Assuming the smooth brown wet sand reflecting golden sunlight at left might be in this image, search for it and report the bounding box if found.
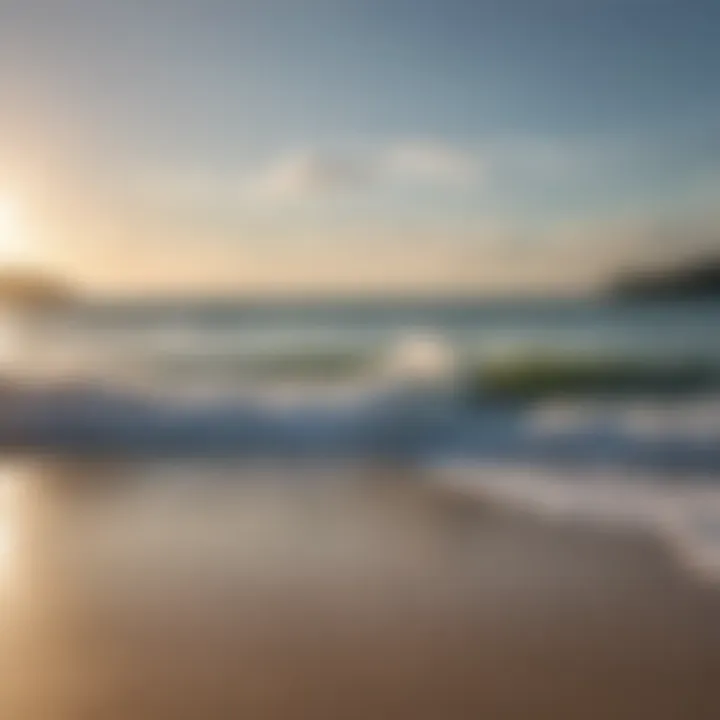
[0,465,720,720]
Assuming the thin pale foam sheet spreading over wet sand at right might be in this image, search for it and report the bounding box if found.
[435,463,720,583]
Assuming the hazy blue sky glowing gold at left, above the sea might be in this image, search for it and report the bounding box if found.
[0,0,720,294]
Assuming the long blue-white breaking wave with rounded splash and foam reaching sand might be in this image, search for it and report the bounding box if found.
[5,335,720,581]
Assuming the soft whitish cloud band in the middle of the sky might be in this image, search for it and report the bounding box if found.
[244,136,592,202]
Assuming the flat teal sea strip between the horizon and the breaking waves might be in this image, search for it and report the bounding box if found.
[71,299,720,379]
